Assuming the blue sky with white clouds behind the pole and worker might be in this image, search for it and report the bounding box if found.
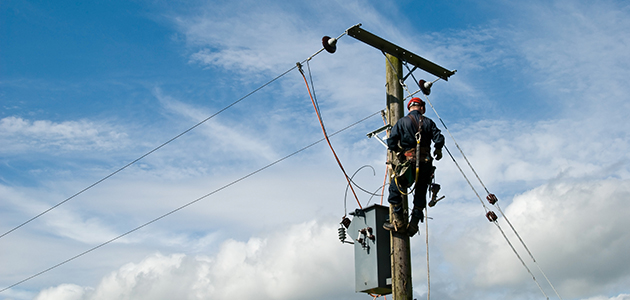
[0,0,630,300]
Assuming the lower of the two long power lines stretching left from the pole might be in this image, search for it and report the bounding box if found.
[0,110,380,293]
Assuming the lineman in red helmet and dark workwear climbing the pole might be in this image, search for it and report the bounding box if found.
[383,98,444,236]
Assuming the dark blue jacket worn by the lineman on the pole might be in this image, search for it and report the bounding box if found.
[387,110,444,151]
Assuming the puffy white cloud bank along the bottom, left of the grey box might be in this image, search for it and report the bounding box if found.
[35,221,360,300]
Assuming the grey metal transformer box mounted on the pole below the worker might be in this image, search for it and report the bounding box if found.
[348,204,392,295]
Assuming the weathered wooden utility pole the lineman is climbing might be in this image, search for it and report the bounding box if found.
[385,54,413,300]
